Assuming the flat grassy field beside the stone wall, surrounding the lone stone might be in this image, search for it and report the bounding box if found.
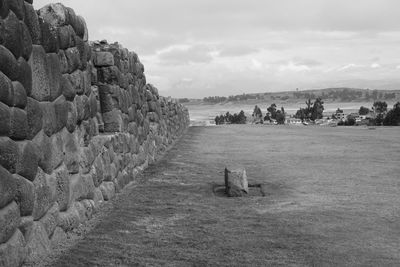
[42,125,400,266]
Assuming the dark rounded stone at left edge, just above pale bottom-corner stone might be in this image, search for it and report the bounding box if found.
[0,201,21,244]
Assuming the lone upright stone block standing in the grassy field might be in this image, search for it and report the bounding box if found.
[225,168,249,197]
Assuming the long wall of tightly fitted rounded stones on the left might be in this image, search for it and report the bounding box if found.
[0,0,189,266]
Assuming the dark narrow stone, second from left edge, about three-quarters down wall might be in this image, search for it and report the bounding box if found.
[13,174,35,216]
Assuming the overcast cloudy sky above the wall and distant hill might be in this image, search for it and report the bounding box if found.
[33,0,400,98]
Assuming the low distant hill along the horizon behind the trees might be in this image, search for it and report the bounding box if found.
[187,87,400,104]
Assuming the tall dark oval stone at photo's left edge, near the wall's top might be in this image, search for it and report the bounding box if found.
[4,11,23,58]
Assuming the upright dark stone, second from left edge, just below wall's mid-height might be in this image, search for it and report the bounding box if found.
[16,141,40,181]
